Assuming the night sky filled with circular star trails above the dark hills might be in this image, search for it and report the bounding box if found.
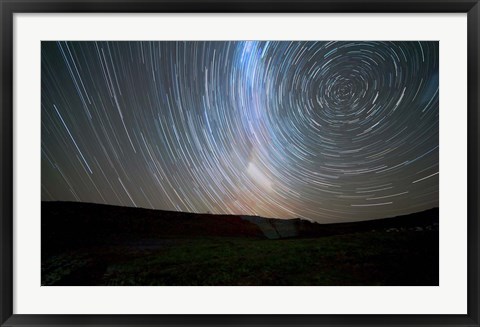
[41,41,439,222]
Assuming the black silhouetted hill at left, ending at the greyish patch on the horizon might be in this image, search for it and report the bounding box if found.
[41,202,264,254]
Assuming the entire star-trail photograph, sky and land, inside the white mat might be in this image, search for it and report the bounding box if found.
[41,41,439,286]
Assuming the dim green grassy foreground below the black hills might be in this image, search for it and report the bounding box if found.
[42,230,439,286]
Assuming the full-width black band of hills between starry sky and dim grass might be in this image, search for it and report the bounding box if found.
[42,202,438,248]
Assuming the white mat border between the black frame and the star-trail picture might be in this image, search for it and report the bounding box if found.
[14,14,464,314]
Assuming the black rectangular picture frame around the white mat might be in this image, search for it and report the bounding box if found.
[0,0,480,327]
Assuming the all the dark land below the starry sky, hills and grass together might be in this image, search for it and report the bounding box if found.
[41,202,439,286]
